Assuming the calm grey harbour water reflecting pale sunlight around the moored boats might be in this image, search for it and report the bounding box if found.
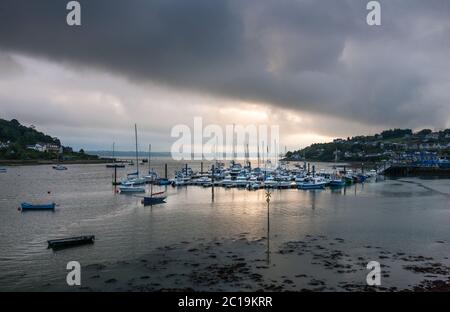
[0,159,450,291]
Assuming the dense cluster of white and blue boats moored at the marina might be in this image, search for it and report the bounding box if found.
[120,162,377,192]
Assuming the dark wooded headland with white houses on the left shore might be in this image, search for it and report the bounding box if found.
[0,118,98,160]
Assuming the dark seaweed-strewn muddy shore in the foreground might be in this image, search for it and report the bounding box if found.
[21,232,450,292]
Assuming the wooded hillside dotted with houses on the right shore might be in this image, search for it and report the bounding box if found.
[285,129,450,161]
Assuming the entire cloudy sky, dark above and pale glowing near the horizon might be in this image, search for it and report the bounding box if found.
[0,0,450,151]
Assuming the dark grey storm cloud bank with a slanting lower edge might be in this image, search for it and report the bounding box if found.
[0,0,450,127]
